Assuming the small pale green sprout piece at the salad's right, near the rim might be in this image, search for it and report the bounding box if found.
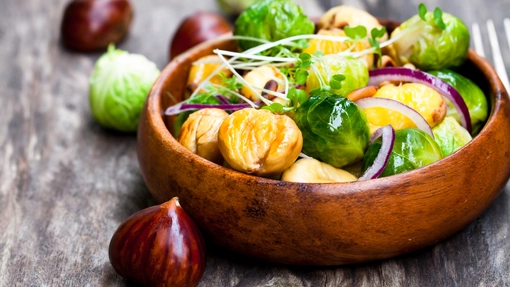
[432,117,472,157]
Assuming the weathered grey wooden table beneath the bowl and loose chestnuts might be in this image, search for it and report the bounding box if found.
[0,0,510,286]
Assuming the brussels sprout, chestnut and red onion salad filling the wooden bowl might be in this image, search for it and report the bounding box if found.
[166,0,488,183]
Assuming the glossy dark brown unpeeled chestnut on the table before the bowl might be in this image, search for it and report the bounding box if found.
[109,197,205,287]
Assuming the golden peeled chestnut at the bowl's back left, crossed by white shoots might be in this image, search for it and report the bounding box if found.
[187,55,232,95]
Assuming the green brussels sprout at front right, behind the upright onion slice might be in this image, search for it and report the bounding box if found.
[361,128,443,177]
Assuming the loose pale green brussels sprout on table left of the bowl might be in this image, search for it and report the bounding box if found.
[89,45,160,132]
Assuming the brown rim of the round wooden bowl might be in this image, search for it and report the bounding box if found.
[145,31,509,193]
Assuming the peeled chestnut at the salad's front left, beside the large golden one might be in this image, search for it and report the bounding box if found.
[179,109,228,164]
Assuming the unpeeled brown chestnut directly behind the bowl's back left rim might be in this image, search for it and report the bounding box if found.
[169,11,232,60]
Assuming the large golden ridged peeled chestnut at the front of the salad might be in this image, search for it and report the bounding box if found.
[218,109,303,176]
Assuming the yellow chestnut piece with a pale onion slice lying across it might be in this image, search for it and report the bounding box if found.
[364,83,446,132]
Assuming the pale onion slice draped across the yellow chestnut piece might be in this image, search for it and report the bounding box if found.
[355,97,434,138]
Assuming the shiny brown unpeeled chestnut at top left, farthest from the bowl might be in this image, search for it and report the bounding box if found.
[61,0,133,52]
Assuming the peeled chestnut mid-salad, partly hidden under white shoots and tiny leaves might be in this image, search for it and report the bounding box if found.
[241,66,283,101]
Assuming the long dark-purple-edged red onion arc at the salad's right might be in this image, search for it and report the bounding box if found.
[368,67,471,133]
